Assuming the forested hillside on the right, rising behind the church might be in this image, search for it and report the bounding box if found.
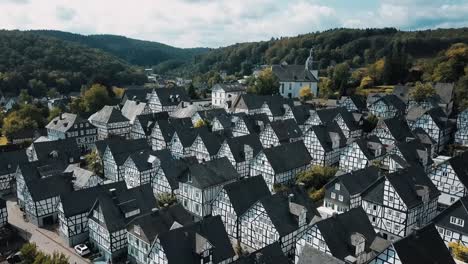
[174,28,468,75]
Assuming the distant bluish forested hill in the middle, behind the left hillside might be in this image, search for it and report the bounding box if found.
[30,30,208,67]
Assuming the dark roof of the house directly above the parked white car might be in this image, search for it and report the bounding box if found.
[60,181,127,217]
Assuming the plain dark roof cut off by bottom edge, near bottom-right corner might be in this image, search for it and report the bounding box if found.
[393,224,455,264]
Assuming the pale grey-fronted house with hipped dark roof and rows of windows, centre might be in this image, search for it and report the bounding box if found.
[177,158,240,218]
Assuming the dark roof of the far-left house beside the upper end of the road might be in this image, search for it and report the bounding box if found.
[25,173,73,202]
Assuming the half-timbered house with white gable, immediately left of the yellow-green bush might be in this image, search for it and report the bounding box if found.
[250,141,312,192]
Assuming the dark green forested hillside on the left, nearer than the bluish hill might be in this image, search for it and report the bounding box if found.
[0,30,146,97]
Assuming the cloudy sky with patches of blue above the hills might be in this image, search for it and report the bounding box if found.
[0,0,468,47]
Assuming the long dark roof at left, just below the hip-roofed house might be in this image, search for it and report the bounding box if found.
[32,138,81,162]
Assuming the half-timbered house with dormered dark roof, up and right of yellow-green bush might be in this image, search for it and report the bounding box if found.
[339,136,386,172]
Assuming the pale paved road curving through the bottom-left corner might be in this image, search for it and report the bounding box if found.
[7,199,90,264]
